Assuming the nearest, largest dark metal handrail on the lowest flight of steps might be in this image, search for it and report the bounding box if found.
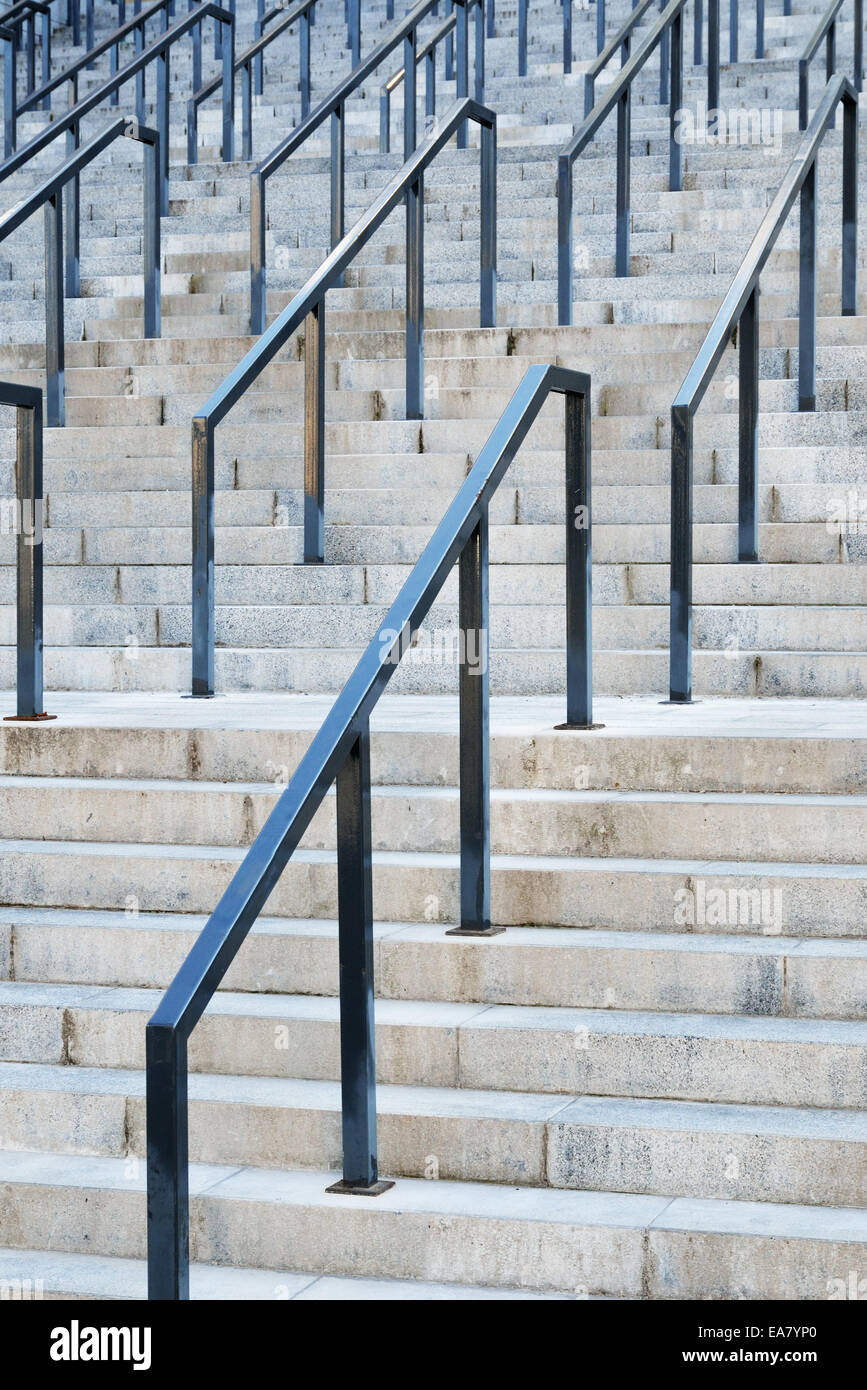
[146,366,592,1300]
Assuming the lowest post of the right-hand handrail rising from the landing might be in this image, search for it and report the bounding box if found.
[668,406,692,705]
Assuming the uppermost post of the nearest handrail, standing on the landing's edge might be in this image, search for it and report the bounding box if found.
[565,392,593,728]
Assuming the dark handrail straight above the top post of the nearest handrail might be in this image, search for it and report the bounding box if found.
[557,0,686,316]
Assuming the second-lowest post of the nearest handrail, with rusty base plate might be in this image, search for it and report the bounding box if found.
[328,721,392,1197]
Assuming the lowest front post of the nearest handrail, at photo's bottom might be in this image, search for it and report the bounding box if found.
[145,1024,189,1301]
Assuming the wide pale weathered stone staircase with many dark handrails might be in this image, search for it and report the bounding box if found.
[0,0,867,1300]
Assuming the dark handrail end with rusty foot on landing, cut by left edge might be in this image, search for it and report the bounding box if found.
[0,381,49,719]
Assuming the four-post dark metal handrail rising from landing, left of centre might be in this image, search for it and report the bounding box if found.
[193,97,496,695]
